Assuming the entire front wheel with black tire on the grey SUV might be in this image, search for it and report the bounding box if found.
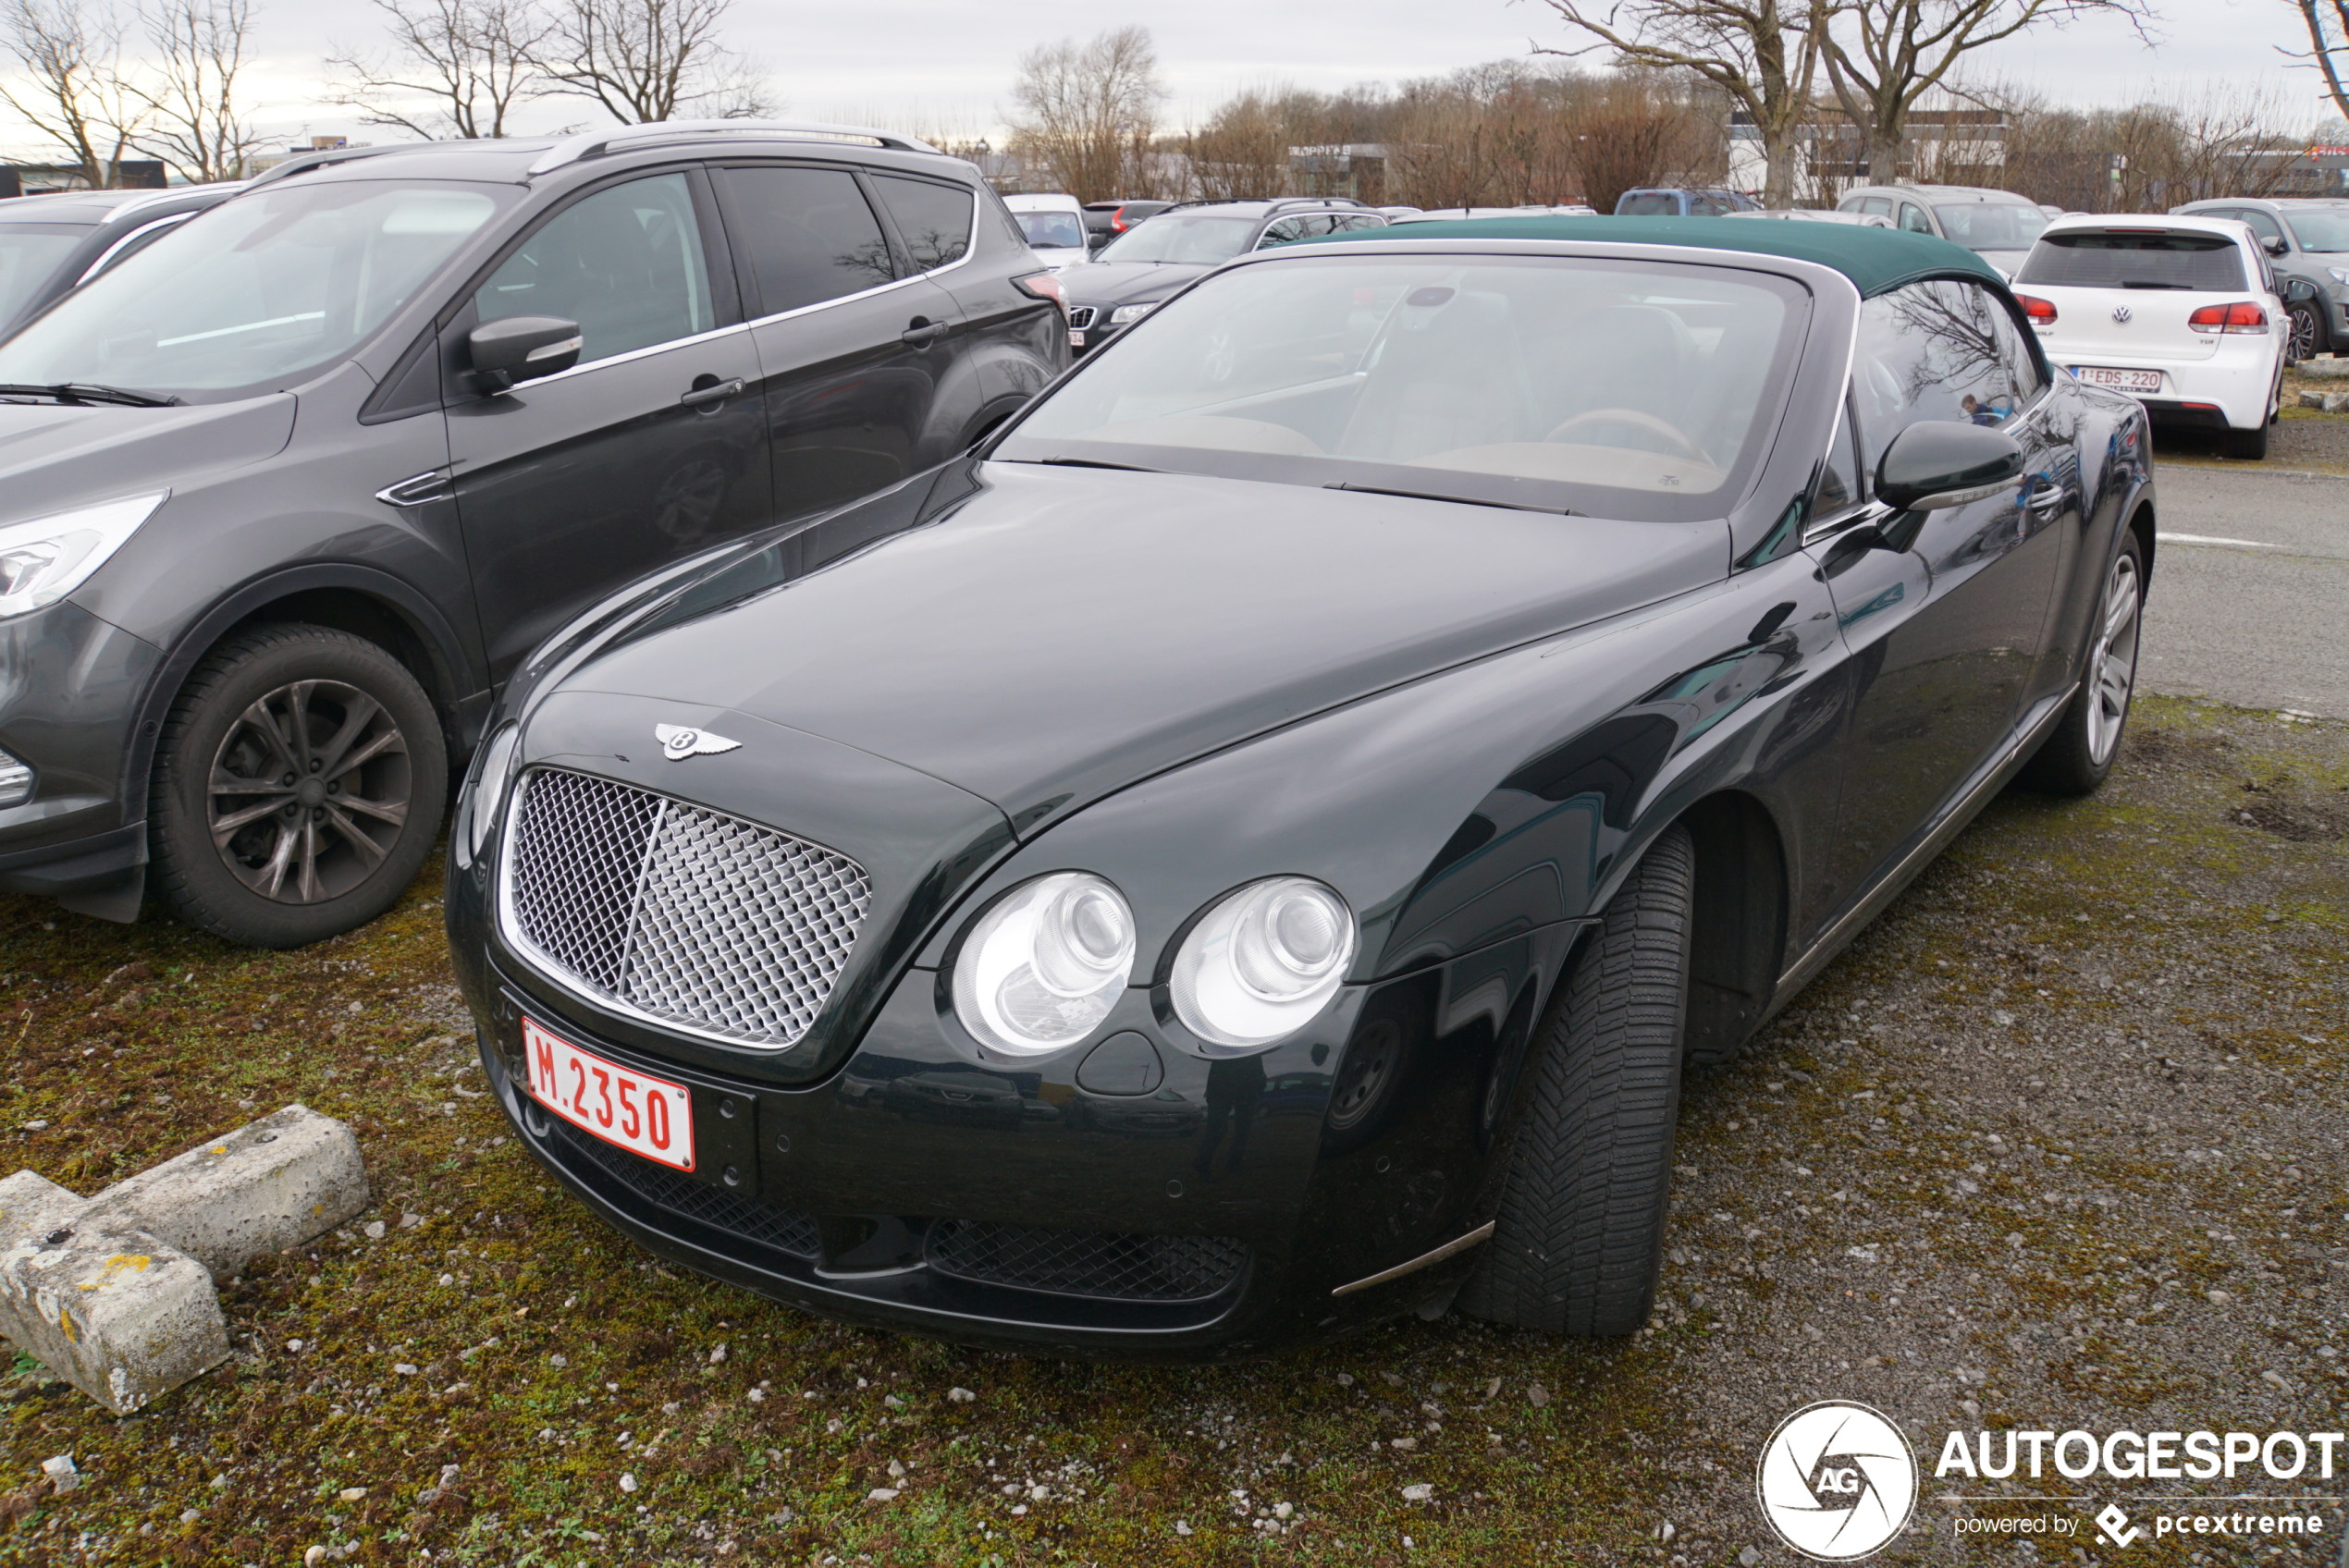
[148,624,449,949]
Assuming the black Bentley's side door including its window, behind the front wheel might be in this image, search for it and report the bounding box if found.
[1809,279,2079,892]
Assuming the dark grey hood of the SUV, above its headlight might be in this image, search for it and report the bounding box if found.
[0,392,294,521]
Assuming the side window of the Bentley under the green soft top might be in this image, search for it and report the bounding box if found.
[1853,279,2041,472]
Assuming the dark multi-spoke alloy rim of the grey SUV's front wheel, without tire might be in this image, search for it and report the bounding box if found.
[207,680,413,903]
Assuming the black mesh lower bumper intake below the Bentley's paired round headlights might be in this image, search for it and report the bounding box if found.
[926,1220,1248,1303]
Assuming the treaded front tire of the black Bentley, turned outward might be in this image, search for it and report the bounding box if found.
[1458,827,1696,1336]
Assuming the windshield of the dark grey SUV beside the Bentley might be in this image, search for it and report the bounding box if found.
[0,180,519,395]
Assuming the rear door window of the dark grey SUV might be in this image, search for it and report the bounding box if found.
[726,165,897,317]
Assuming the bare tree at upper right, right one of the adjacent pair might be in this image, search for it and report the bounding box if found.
[1811,0,2152,186]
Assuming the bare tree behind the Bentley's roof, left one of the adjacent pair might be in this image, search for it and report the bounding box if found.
[1543,0,1821,206]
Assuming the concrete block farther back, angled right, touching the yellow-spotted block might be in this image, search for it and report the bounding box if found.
[94,1106,371,1280]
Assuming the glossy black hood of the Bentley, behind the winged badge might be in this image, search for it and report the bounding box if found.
[561,462,1728,838]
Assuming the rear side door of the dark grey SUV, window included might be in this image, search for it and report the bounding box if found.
[719,162,967,519]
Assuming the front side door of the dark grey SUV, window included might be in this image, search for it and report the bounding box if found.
[449,169,769,680]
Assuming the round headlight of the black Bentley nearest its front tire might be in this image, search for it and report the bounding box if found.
[1170,876,1356,1047]
